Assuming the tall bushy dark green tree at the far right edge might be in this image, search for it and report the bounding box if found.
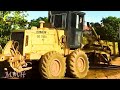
[101,16,120,41]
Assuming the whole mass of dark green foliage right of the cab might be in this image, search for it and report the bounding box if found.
[92,16,120,41]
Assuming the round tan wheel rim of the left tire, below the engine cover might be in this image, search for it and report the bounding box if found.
[50,59,61,76]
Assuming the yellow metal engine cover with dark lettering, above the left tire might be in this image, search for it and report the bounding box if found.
[19,28,64,60]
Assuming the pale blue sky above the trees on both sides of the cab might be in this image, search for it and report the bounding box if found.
[27,11,120,22]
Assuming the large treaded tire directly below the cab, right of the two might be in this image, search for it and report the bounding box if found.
[67,49,89,78]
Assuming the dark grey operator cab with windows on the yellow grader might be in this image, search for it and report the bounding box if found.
[48,11,85,49]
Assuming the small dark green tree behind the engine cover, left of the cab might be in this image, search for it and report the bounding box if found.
[29,17,48,28]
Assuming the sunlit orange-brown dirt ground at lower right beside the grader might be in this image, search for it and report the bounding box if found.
[65,57,120,79]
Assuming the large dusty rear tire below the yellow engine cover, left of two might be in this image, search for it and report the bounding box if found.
[39,51,66,79]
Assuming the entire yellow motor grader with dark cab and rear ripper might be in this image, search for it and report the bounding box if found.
[0,11,111,79]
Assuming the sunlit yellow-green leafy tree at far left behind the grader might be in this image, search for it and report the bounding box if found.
[0,11,27,47]
